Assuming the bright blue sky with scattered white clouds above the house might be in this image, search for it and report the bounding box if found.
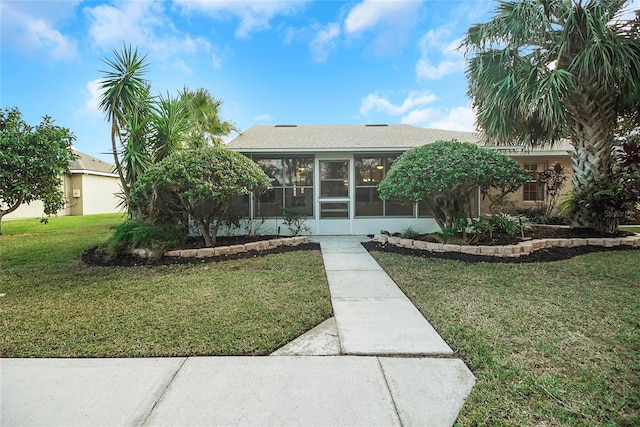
[0,0,640,161]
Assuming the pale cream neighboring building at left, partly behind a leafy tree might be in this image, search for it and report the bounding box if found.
[3,148,120,219]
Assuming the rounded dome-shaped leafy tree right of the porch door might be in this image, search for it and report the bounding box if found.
[378,141,529,230]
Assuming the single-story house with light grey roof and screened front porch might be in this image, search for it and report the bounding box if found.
[227,124,571,235]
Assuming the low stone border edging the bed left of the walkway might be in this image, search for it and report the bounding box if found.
[131,236,309,259]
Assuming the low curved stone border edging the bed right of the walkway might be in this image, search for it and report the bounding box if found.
[372,234,640,258]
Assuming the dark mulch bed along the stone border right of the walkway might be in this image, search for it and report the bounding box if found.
[363,226,636,263]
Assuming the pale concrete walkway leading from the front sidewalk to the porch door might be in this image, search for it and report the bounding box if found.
[0,237,475,426]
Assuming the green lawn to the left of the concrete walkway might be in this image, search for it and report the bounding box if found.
[0,215,332,357]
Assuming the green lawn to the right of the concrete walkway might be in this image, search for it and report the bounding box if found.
[373,250,640,426]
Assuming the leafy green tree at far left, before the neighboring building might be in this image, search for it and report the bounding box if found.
[0,107,75,234]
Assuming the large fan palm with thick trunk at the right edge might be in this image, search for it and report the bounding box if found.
[462,0,640,232]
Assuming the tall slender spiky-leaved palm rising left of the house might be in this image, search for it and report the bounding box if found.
[100,46,150,212]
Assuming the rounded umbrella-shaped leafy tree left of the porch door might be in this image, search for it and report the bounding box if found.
[132,147,270,246]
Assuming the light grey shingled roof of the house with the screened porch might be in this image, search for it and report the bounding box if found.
[227,124,572,156]
